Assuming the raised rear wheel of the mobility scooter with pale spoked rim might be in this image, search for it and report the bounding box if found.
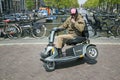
[86,46,98,60]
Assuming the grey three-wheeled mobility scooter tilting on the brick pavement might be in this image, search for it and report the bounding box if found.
[40,27,98,71]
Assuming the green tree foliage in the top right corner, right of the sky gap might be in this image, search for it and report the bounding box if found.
[84,0,120,12]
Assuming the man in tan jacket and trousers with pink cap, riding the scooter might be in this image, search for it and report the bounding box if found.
[56,8,85,57]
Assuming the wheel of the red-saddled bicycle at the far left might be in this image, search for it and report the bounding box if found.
[5,24,21,39]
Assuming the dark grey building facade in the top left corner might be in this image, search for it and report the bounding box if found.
[0,0,25,14]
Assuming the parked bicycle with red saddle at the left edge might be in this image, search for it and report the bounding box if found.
[0,19,20,39]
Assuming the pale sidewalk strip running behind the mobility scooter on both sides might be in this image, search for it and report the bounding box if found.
[0,37,120,46]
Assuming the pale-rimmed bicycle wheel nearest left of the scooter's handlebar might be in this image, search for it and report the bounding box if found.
[32,24,47,38]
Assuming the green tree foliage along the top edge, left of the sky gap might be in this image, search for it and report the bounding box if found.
[25,0,79,10]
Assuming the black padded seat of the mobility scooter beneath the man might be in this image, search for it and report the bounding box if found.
[66,37,87,45]
